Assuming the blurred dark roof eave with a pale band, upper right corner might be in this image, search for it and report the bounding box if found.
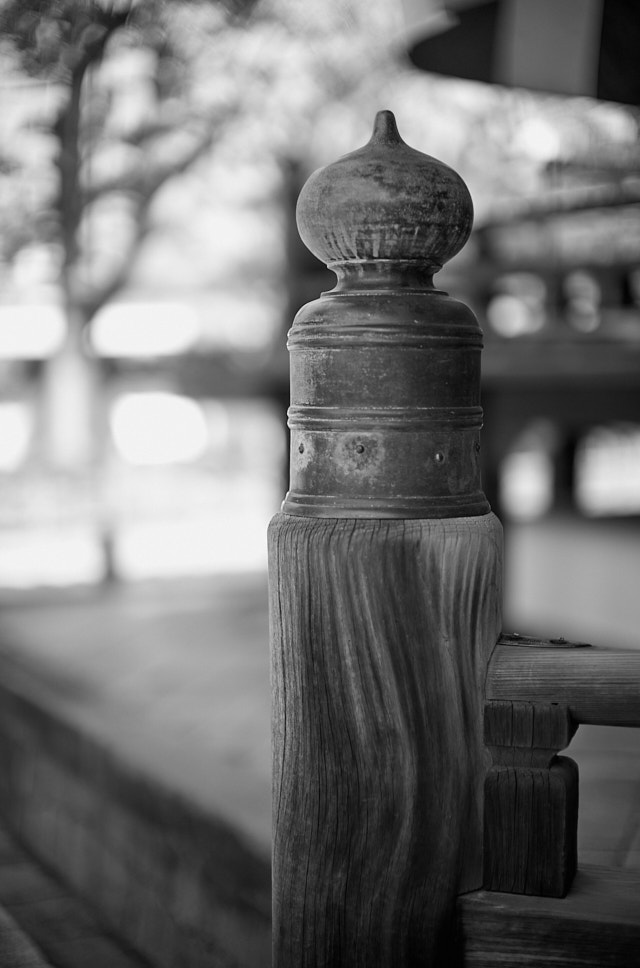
[402,0,640,107]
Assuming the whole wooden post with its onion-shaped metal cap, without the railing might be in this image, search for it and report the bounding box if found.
[269,111,502,968]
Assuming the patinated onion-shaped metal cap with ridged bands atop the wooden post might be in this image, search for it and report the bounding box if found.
[283,111,489,518]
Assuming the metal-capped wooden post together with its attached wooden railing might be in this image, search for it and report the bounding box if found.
[269,112,640,968]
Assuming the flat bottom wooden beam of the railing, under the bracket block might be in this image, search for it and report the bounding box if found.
[458,867,640,968]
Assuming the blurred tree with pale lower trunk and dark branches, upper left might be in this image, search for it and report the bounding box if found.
[0,0,253,468]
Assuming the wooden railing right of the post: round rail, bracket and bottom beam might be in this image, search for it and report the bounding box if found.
[458,635,640,968]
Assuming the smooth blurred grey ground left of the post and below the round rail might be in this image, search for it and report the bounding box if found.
[0,574,640,869]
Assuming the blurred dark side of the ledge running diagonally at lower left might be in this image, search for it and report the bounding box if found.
[0,672,270,968]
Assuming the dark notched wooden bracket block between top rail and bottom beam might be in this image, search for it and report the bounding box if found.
[484,701,578,897]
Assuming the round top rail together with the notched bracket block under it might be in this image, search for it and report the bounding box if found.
[484,635,640,896]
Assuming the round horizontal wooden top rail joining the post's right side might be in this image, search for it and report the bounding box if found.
[485,636,640,726]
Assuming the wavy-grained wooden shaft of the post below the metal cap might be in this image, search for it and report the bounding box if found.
[269,514,502,968]
